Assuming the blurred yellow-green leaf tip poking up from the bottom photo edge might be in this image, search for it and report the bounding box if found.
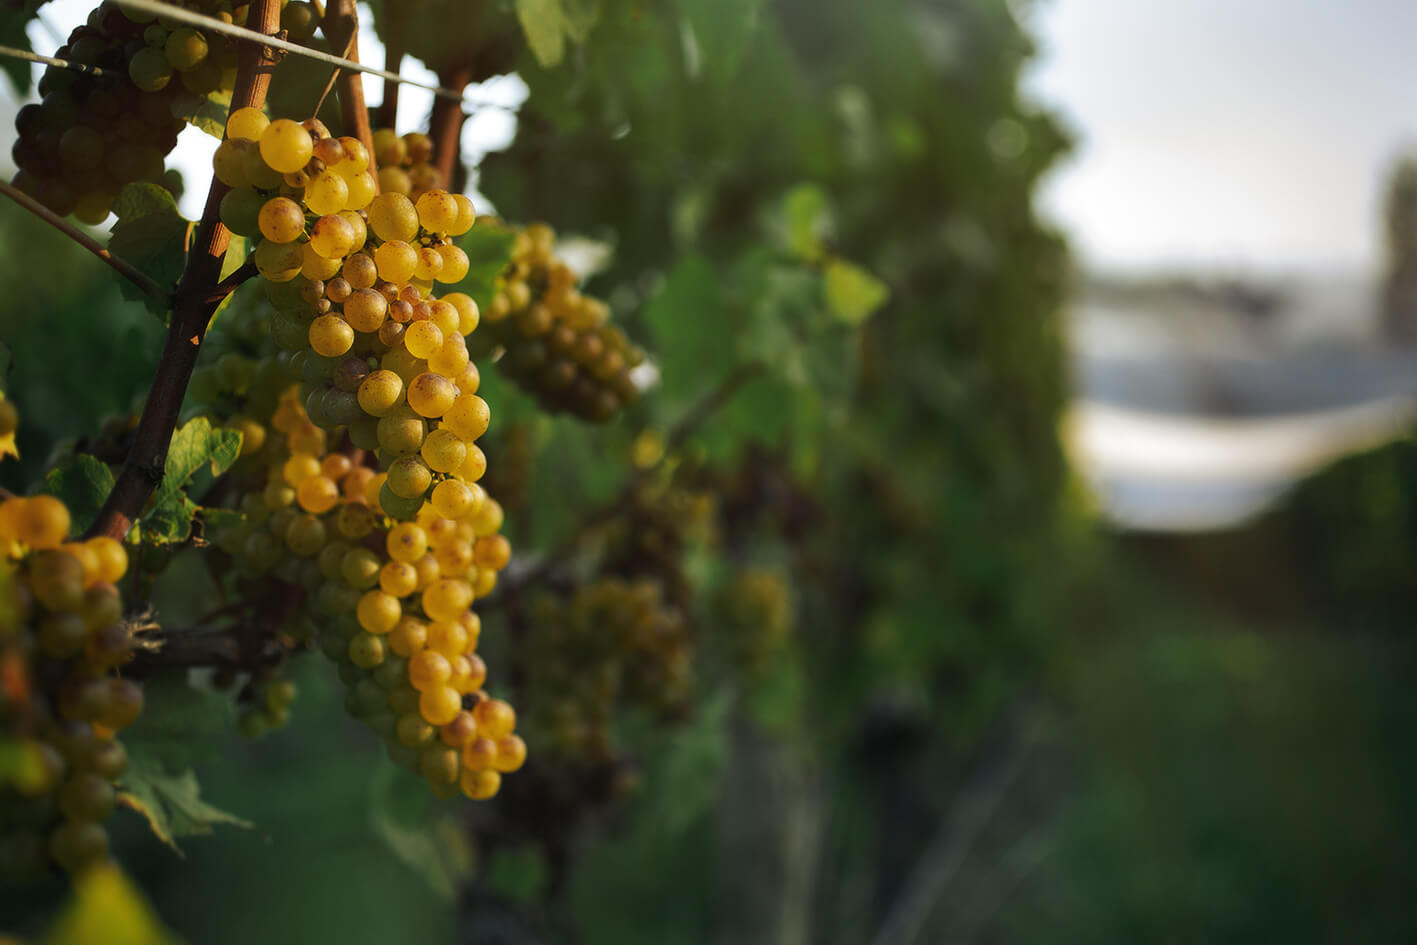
[41,864,181,945]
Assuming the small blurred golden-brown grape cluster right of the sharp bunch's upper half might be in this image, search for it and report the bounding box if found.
[482,224,645,422]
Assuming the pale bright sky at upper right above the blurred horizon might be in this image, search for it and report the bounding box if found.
[1029,0,1417,269]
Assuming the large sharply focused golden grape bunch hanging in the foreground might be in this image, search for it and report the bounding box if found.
[198,109,526,799]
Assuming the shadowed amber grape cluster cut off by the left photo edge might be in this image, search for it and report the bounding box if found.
[0,496,143,880]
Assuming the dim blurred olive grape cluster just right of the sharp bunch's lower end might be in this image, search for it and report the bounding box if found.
[530,578,693,762]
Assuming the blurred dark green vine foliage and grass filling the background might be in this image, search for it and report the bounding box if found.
[0,0,1417,945]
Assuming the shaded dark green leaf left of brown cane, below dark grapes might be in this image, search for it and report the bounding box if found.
[108,183,188,320]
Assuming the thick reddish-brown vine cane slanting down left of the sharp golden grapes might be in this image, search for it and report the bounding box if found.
[88,0,281,538]
